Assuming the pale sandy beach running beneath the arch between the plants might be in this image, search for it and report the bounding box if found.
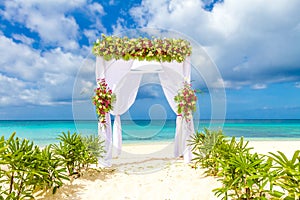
[39,141,300,200]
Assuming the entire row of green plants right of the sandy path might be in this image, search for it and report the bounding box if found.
[190,129,286,200]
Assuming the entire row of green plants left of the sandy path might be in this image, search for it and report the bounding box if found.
[0,132,103,200]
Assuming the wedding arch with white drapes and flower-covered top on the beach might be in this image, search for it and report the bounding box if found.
[93,35,196,166]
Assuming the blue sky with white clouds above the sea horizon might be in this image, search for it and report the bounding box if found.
[0,0,300,120]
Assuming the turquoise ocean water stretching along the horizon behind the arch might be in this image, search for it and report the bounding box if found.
[0,119,300,146]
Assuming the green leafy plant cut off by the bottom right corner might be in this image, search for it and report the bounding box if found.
[270,150,300,200]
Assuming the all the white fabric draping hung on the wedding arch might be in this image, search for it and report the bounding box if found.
[95,57,194,163]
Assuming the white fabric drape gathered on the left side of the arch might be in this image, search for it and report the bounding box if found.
[96,57,142,160]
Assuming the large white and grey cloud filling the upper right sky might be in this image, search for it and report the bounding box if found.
[130,0,300,87]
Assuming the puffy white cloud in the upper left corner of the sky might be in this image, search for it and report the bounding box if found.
[2,0,85,50]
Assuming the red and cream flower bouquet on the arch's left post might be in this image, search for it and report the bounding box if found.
[92,78,116,125]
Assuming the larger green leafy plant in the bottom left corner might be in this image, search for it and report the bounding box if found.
[0,133,67,199]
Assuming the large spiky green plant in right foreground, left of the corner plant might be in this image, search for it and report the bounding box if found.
[213,151,272,200]
